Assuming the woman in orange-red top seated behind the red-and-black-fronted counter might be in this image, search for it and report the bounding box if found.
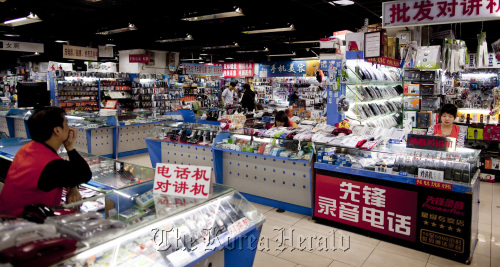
[427,104,467,147]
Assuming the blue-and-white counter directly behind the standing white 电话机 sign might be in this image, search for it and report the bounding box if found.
[146,122,220,171]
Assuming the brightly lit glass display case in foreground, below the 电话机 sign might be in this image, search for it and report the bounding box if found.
[57,182,265,266]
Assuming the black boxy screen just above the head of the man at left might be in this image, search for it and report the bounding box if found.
[17,82,50,109]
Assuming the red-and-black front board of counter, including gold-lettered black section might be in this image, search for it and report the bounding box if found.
[314,169,479,262]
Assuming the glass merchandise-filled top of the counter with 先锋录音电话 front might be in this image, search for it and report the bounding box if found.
[316,144,480,186]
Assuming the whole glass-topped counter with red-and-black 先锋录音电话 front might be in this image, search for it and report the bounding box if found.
[313,144,480,263]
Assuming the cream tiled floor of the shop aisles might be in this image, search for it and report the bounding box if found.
[120,154,500,267]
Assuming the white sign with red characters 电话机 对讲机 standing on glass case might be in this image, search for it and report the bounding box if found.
[153,163,212,198]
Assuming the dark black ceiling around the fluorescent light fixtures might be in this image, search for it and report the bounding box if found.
[0,0,500,69]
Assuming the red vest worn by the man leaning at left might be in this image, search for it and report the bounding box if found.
[0,142,63,216]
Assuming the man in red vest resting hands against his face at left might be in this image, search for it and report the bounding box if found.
[0,107,92,216]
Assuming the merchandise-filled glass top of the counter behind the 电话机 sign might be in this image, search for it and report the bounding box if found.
[148,122,220,146]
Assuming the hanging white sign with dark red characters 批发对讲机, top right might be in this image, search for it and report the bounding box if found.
[382,0,500,28]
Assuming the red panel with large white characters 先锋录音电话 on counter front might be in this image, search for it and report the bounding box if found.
[314,174,417,242]
